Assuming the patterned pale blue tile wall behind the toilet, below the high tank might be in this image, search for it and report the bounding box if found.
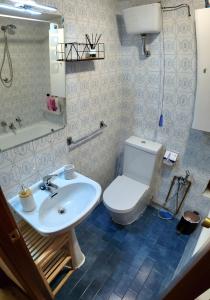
[119,0,210,215]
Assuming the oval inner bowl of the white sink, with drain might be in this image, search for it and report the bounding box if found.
[39,182,97,231]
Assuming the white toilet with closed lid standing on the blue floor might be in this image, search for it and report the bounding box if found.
[103,136,163,225]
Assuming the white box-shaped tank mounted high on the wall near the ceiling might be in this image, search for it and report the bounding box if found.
[123,3,162,34]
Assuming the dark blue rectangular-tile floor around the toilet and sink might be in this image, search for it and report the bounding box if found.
[56,204,188,300]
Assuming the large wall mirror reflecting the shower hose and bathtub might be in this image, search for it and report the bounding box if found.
[0,7,66,151]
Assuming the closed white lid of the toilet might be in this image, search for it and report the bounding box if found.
[103,175,149,213]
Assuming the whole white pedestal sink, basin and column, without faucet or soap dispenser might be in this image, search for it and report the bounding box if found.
[9,168,101,269]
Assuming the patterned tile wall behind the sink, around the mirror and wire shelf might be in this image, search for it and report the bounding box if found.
[0,0,124,197]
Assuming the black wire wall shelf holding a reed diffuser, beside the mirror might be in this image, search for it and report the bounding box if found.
[56,43,105,62]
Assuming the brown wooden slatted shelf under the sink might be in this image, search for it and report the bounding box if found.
[18,221,74,297]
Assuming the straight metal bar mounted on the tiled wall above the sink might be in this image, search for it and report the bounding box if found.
[67,121,107,150]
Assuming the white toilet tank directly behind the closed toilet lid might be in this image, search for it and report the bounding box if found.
[123,136,162,186]
